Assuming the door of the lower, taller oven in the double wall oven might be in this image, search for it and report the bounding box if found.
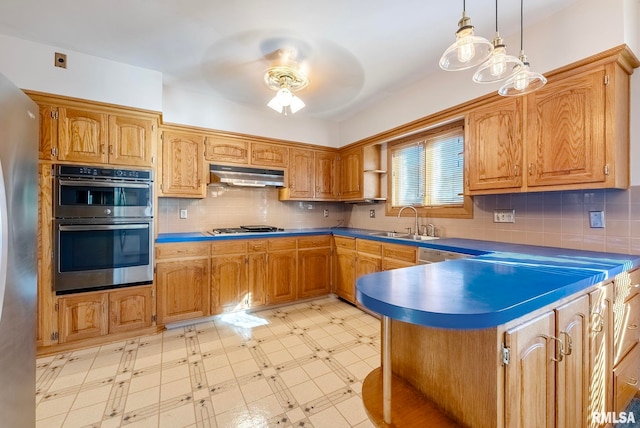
[53,219,153,294]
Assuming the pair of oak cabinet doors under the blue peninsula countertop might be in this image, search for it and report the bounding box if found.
[504,295,589,428]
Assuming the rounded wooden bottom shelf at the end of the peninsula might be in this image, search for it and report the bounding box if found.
[362,367,462,428]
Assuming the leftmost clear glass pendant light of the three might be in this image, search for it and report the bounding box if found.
[439,0,493,71]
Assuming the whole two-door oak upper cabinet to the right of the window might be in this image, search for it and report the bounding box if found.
[466,46,640,195]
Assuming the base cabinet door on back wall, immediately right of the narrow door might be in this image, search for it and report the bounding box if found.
[267,250,298,303]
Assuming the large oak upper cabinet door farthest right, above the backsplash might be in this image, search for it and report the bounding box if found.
[527,67,608,186]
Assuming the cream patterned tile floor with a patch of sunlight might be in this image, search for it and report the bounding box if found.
[36,297,380,428]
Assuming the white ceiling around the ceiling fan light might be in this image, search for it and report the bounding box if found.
[0,0,577,120]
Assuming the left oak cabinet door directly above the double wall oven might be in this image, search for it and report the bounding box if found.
[58,107,109,164]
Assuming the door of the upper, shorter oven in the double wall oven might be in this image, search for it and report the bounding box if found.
[53,178,153,218]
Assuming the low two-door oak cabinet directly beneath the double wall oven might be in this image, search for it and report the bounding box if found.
[58,285,153,343]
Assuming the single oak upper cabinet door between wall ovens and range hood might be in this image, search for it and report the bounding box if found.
[160,132,206,198]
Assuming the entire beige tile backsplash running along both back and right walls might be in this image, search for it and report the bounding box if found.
[156,186,640,254]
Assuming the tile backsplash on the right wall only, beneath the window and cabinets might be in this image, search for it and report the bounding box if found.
[346,186,640,254]
